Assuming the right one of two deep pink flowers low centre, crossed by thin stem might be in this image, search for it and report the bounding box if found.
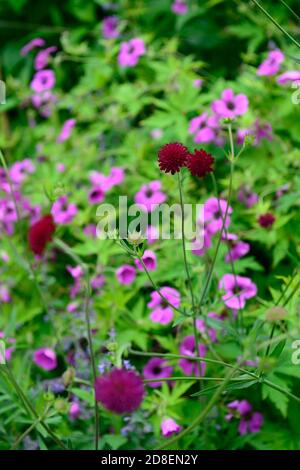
[178,336,206,376]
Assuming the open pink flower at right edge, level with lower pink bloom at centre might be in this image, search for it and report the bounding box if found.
[219,274,257,310]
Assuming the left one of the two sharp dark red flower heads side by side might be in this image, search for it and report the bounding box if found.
[158,142,189,175]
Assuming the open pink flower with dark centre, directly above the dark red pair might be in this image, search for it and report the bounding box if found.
[212,88,249,119]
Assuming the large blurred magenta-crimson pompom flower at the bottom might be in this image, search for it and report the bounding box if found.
[95,369,144,414]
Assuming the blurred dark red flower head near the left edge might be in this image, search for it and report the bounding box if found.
[28,214,55,256]
